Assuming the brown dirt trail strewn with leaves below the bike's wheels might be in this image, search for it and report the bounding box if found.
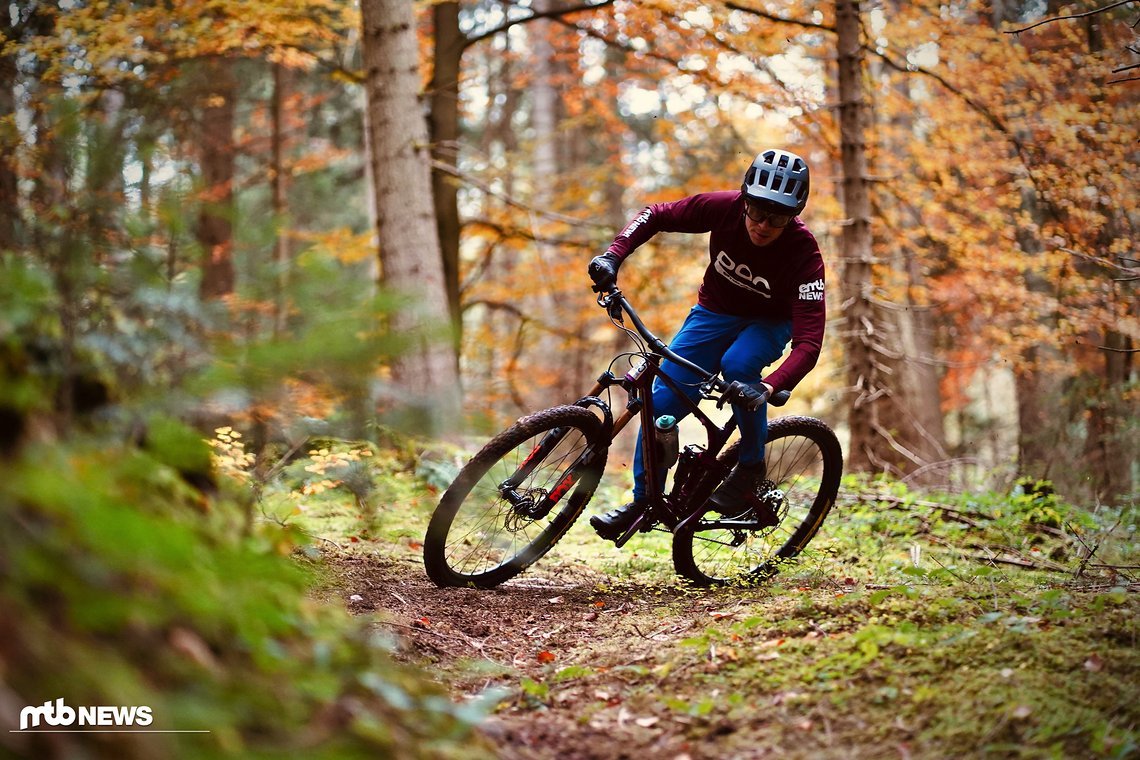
[334,555,787,760]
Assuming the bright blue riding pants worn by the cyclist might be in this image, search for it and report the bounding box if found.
[634,304,791,499]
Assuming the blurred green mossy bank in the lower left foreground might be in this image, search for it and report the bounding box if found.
[0,428,486,758]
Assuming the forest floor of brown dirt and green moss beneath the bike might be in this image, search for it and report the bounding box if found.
[326,510,1140,760]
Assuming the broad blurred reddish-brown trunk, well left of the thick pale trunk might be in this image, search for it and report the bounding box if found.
[195,58,237,299]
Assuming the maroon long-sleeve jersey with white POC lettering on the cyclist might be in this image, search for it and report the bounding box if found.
[610,190,827,391]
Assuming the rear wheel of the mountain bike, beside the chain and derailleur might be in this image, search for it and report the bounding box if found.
[673,417,844,586]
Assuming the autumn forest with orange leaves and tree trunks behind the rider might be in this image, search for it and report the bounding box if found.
[0,0,1140,500]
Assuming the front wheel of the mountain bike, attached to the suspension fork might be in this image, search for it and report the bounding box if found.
[424,406,609,588]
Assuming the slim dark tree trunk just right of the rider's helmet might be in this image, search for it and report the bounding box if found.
[836,0,886,472]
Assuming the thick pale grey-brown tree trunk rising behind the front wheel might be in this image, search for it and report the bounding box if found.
[360,0,461,434]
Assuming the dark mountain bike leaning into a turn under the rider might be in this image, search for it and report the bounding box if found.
[424,288,842,588]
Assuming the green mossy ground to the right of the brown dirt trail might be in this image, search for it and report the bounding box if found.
[673,582,1140,758]
